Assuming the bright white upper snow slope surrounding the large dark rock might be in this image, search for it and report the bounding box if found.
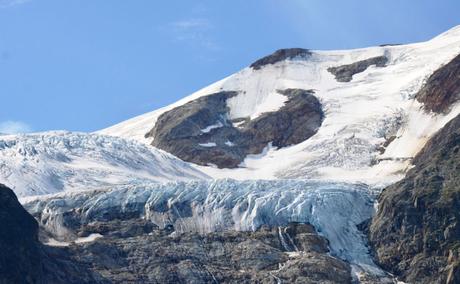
[101,26,460,186]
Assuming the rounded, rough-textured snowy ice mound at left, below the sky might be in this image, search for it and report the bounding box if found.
[0,132,207,196]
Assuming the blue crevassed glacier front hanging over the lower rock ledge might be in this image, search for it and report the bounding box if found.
[21,179,379,273]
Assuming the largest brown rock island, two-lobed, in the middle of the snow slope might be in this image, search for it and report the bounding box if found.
[146,89,324,168]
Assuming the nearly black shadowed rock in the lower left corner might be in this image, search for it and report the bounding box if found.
[0,184,109,284]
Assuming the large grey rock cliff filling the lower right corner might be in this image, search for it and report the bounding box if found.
[369,113,460,283]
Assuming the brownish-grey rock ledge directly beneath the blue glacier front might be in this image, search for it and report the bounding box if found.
[45,221,351,283]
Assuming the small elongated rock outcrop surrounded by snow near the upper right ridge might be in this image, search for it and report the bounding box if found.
[327,56,388,82]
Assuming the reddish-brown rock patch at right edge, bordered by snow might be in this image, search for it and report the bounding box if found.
[416,55,460,113]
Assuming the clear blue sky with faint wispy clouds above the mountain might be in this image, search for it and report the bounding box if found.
[0,0,460,133]
